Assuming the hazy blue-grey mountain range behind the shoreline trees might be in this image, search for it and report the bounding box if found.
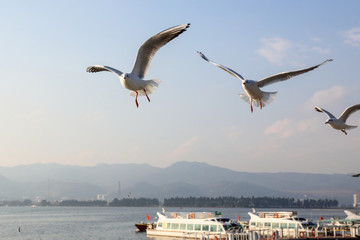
[0,162,360,204]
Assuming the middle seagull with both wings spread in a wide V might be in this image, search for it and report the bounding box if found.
[198,52,332,112]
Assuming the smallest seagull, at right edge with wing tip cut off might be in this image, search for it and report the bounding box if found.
[315,104,360,135]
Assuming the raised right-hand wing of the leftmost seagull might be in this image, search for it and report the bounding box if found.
[132,23,190,78]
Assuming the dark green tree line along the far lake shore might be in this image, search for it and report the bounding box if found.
[0,197,339,209]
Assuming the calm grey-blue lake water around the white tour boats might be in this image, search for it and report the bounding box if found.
[0,207,345,240]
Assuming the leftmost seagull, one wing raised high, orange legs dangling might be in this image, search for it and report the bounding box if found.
[86,23,190,107]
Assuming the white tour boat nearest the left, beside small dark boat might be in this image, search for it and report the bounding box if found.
[146,212,243,239]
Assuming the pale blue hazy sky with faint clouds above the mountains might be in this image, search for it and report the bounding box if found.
[0,0,360,173]
